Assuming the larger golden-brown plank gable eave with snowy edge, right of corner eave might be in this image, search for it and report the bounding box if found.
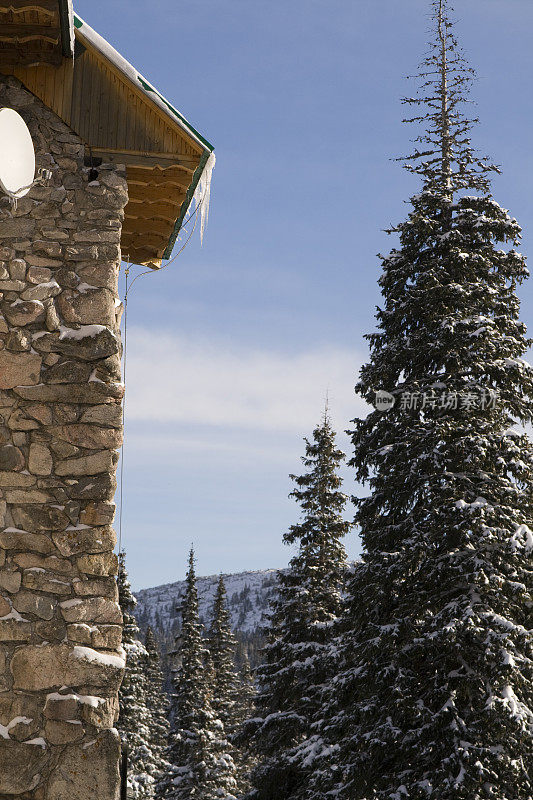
[0,11,213,268]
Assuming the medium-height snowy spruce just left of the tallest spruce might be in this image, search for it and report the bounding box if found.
[240,411,350,800]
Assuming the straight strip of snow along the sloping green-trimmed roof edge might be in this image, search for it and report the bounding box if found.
[74,14,214,153]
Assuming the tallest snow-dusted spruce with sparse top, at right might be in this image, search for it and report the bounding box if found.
[313,0,533,800]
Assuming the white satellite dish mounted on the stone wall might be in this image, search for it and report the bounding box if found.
[0,108,35,200]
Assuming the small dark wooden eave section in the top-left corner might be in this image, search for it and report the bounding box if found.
[0,0,72,70]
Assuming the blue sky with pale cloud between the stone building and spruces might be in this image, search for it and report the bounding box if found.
[76,0,533,588]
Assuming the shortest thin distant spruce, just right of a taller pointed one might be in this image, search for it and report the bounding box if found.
[208,575,242,735]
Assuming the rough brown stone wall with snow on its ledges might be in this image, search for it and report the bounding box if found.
[0,75,127,800]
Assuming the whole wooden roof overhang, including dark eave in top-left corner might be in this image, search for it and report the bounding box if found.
[0,7,213,269]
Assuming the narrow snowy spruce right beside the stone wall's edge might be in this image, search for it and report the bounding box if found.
[117,552,158,798]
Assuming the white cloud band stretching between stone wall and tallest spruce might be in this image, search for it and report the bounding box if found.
[127,328,366,434]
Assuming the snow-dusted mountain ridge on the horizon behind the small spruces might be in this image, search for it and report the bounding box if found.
[135,569,278,635]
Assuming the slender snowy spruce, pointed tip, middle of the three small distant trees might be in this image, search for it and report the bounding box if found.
[157,549,236,800]
